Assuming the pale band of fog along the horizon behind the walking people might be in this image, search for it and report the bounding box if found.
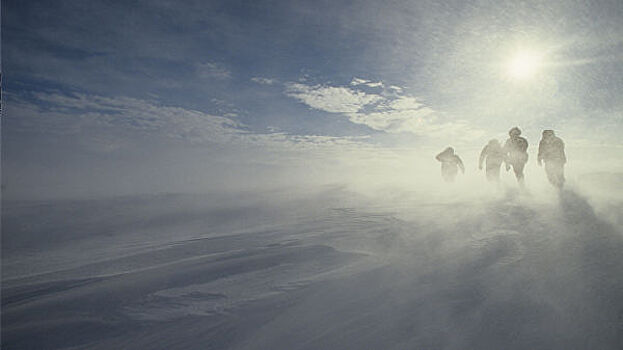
[3,123,623,200]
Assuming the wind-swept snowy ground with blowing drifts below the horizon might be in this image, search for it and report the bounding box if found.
[2,188,623,350]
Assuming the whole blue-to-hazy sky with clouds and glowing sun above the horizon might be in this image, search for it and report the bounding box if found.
[2,0,623,198]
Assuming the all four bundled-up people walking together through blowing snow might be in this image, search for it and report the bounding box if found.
[436,127,567,188]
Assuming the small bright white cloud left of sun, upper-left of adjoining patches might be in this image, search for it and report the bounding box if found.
[286,83,383,113]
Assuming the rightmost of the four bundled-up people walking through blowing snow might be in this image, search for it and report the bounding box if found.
[537,130,567,188]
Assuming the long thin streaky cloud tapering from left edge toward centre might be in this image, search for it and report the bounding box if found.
[6,92,366,150]
